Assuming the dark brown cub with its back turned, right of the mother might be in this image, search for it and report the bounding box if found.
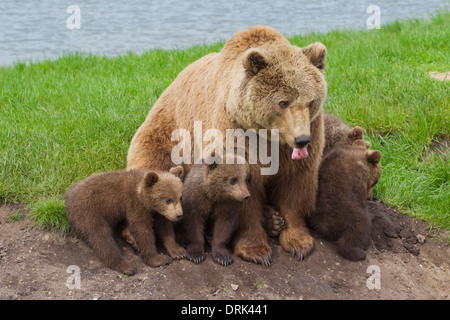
[308,145,382,261]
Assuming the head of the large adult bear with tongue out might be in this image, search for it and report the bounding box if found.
[238,44,326,148]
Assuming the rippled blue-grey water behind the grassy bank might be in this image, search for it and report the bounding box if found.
[0,0,448,65]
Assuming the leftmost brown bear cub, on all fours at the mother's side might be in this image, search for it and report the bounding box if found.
[64,166,184,275]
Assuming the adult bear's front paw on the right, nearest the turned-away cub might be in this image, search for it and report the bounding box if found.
[279,228,314,260]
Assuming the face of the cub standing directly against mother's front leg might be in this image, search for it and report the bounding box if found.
[206,163,250,202]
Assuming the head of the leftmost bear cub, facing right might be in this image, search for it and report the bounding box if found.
[138,167,183,221]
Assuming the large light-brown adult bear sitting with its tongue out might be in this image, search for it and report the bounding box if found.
[127,26,327,264]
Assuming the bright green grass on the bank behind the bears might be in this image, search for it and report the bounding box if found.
[0,11,450,231]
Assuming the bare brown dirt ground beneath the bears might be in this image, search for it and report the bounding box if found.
[0,201,450,300]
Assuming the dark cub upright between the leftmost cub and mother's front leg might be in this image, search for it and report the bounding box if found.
[183,152,250,266]
